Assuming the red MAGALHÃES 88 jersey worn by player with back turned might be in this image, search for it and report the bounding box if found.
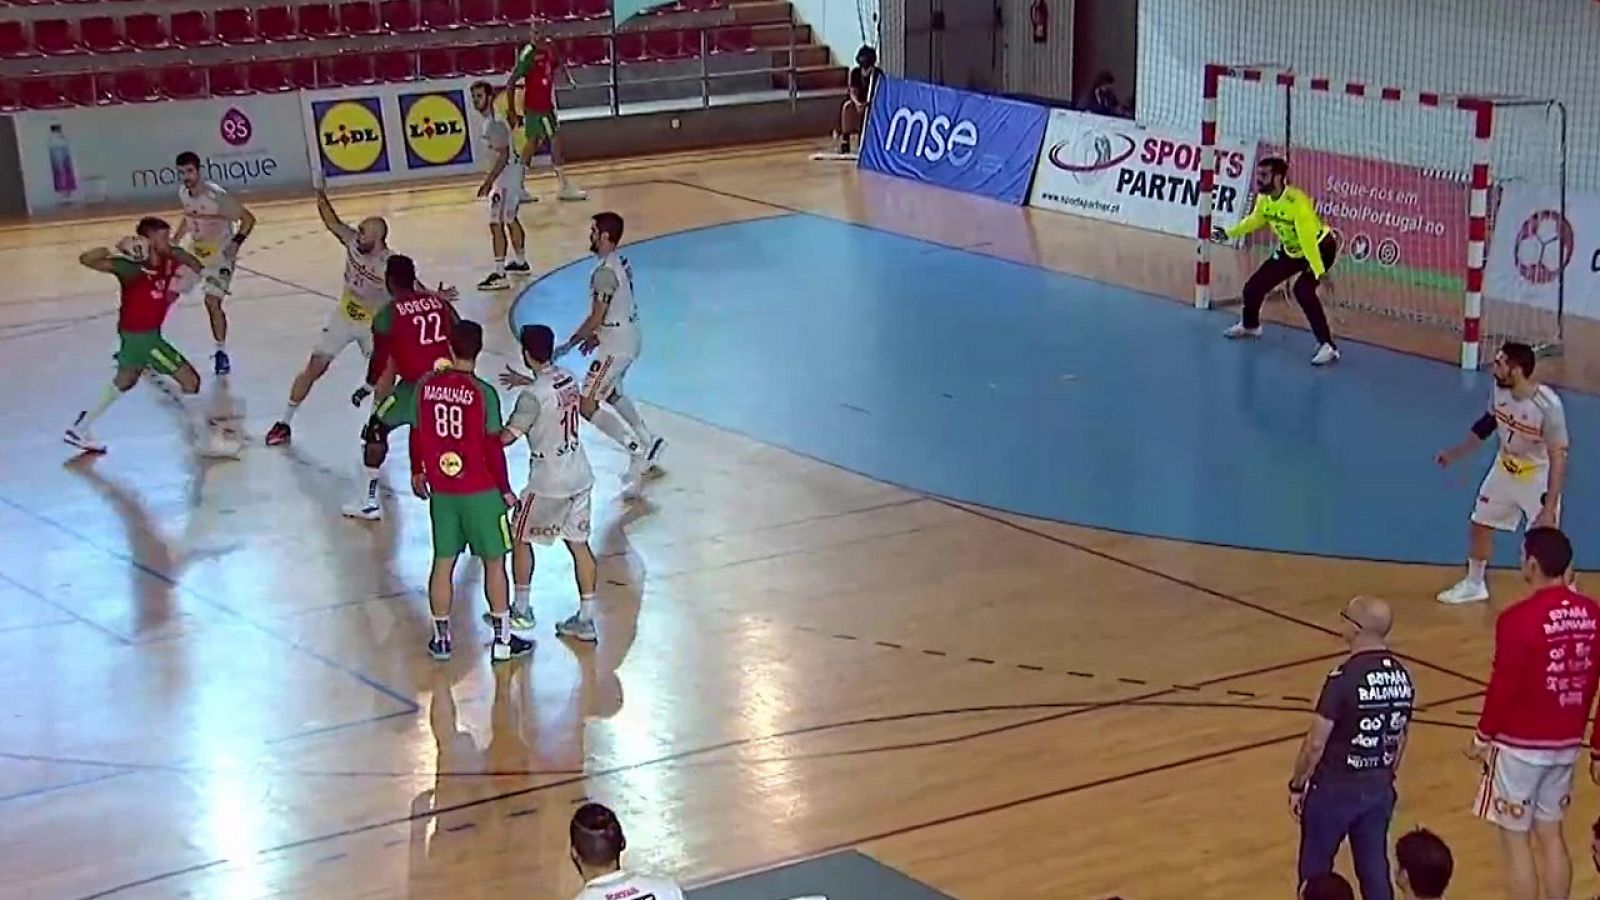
[411,368,512,495]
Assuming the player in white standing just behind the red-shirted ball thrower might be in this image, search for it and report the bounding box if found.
[173,151,256,375]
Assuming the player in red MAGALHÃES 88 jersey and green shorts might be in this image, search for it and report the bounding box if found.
[411,320,533,663]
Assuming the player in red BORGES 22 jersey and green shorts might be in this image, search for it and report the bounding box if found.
[344,253,458,522]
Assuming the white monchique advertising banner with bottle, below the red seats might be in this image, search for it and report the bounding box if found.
[14,94,310,215]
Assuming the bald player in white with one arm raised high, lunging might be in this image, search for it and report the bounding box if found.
[267,191,392,447]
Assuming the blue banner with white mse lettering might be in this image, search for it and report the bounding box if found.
[859,75,1050,207]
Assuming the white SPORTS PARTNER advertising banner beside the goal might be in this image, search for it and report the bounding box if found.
[1027,109,1254,237]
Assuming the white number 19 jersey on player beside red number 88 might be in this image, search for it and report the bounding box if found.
[506,365,595,496]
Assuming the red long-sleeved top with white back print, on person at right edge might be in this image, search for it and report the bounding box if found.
[1478,585,1600,755]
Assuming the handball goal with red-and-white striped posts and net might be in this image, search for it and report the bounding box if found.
[1195,64,1573,368]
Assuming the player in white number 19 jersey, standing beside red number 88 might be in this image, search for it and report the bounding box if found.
[501,325,597,642]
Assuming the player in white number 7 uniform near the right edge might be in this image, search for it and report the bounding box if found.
[1437,341,1566,604]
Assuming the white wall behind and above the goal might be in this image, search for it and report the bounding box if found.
[1138,0,1600,189]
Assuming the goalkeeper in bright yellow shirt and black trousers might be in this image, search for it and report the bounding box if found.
[1211,157,1339,365]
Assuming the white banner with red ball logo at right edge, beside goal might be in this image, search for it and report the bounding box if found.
[1483,184,1600,319]
